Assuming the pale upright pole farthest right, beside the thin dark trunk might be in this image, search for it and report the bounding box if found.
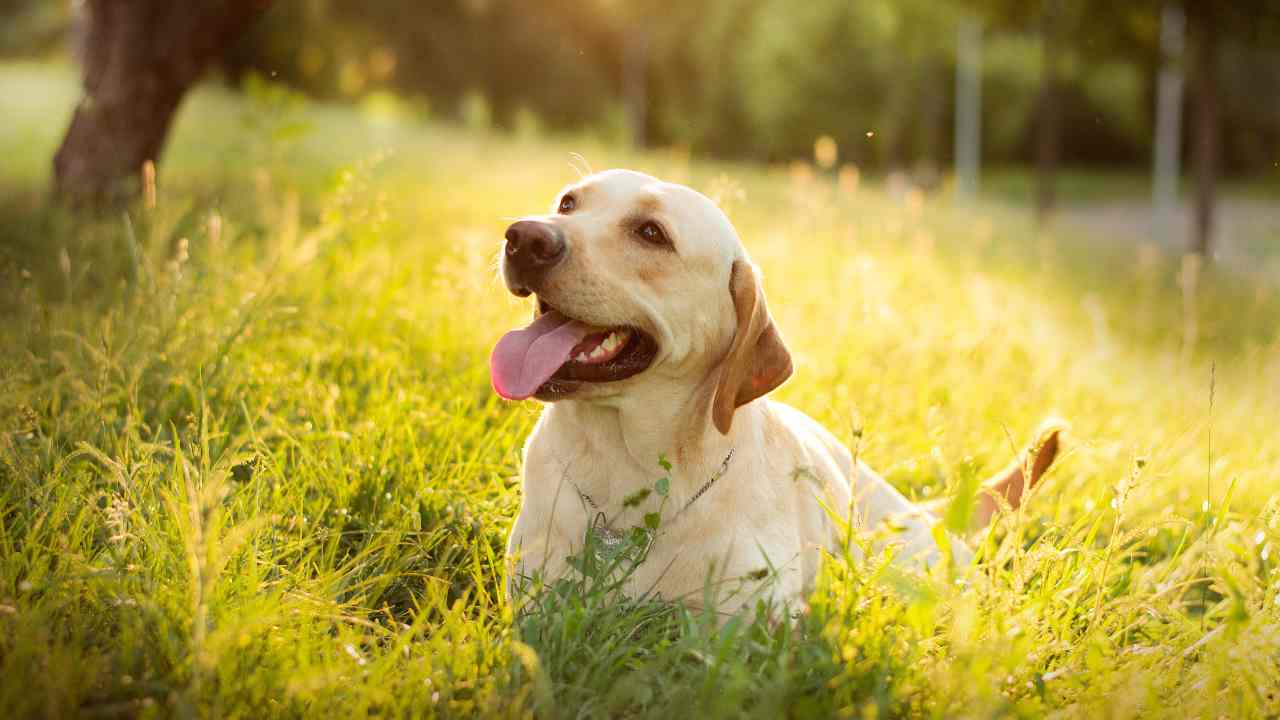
[1151,5,1187,236]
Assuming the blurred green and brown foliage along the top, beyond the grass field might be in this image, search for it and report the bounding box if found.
[0,0,1280,174]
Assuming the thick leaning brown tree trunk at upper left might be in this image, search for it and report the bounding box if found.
[54,0,270,205]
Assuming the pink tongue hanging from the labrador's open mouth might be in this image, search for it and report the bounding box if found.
[489,310,599,400]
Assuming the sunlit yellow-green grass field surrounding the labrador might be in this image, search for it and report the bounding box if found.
[0,64,1280,719]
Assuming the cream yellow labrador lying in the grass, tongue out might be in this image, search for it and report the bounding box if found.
[490,170,1057,612]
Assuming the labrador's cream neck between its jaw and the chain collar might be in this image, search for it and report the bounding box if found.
[548,371,740,492]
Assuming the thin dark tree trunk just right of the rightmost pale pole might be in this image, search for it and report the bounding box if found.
[1190,12,1221,259]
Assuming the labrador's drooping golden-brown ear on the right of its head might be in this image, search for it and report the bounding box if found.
[712,260,791,434]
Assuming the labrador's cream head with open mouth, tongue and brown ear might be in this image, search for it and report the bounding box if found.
[490,170,791,433]
